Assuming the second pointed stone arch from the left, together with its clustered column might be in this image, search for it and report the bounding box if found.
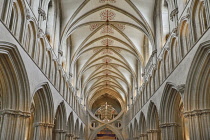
[30,83,54,140]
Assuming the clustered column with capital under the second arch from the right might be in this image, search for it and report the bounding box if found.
[160,123,182,140]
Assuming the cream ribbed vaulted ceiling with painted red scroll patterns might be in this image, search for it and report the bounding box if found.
[61,0,155,109]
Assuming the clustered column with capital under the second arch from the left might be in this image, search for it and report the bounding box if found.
[34,123,54,140]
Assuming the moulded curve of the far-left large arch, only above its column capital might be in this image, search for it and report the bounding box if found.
[0,42,30,111]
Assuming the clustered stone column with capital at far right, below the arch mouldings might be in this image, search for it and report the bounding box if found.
[184,109,210,140]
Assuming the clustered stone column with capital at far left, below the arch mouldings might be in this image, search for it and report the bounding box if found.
[0,110,30,140]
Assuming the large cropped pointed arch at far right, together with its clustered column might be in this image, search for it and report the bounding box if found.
[184,41,210,140]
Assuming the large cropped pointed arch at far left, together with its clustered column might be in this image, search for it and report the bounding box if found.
[0,42,30,139]
